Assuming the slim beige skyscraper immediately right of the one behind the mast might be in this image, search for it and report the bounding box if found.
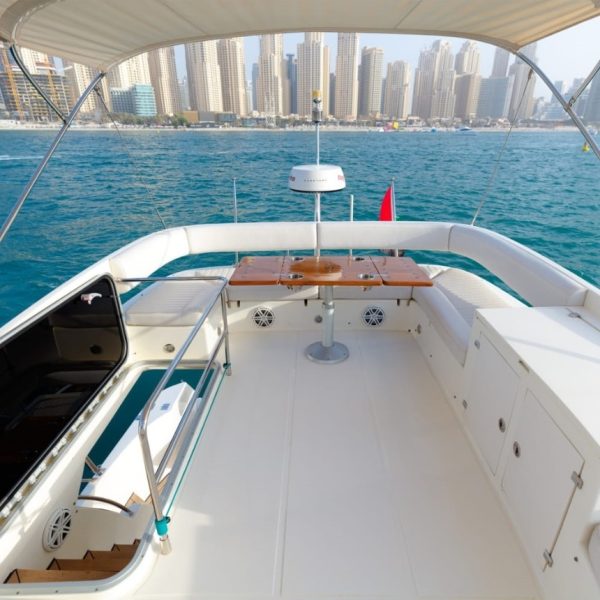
[333,33,359,121]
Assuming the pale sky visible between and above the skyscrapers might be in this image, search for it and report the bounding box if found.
[176,17,600,98]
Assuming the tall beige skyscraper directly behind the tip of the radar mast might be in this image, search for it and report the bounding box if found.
[296,32,329,117]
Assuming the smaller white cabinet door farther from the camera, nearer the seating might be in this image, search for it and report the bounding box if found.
[466,334,519,474]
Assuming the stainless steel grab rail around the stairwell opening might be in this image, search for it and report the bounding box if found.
[118,275,231,554]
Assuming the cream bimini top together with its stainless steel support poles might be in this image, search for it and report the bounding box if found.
[0,9,600,242]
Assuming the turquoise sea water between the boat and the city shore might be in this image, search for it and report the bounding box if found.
[0,130,600,324]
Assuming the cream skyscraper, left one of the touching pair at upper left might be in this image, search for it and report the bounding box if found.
[185,40,223,112]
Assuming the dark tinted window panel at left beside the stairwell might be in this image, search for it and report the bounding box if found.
[0,277,126,505]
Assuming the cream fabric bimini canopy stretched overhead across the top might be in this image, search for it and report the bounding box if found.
[0,0,600,71]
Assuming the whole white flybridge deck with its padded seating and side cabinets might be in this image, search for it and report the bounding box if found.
[0,222,600,600]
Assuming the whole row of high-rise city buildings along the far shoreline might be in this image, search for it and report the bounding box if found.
[0,22,596,124]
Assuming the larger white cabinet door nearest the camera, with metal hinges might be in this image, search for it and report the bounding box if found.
[502,390,584,568]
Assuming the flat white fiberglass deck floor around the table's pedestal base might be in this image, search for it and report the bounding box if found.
[139,332,538,600]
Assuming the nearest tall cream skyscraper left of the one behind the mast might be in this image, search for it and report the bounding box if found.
[256,33,283,115]
